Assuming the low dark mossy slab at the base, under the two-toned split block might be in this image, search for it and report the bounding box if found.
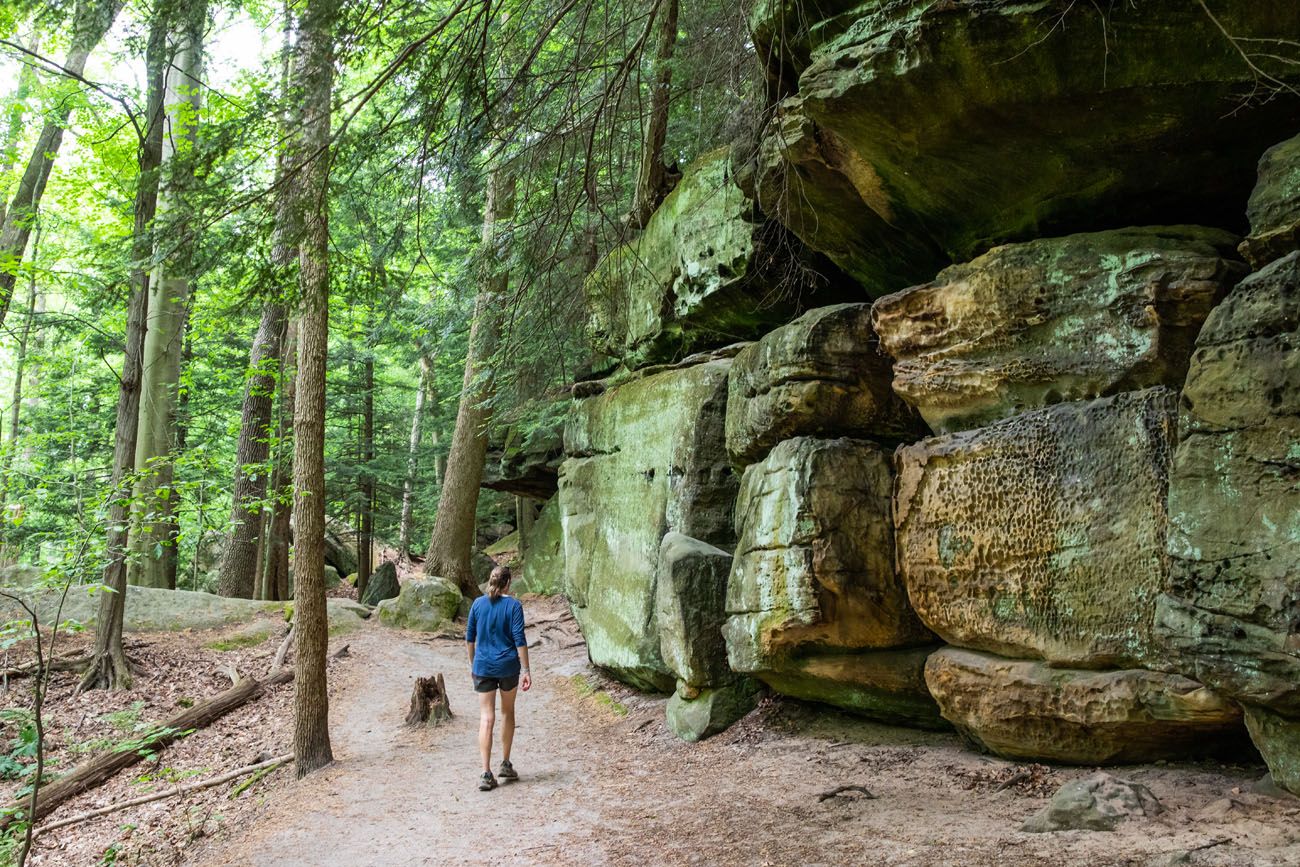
[758,645,949,729]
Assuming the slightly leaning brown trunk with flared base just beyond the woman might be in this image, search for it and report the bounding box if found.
[424,162,515,598]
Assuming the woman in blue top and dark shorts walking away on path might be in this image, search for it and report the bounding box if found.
[465,565,533,792]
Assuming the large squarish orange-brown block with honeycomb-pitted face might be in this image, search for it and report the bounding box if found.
[894,389,1177,668]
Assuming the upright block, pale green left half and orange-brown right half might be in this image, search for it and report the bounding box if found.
[723,437,933,673]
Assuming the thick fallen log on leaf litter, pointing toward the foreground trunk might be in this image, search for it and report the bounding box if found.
[0,668,294,831]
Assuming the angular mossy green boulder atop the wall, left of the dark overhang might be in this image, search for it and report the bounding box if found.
[585,149,855,369]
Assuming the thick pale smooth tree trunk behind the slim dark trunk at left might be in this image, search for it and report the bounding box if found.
[129,0,208,590]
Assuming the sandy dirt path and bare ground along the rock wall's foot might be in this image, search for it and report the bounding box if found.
[7,599,1300,867]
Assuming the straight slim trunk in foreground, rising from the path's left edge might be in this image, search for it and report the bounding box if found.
[291,0,337,779]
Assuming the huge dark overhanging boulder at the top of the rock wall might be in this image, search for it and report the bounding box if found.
[755,0,1300,274]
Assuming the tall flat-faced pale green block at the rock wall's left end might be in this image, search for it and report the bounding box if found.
[559,359,737,693]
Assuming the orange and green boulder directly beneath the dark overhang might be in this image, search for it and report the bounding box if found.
[872,226,1247,433]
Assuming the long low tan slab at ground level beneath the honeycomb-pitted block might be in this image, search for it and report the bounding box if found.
[926,647,1243,764]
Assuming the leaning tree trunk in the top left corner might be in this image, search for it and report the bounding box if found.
[0,0,124,326]
